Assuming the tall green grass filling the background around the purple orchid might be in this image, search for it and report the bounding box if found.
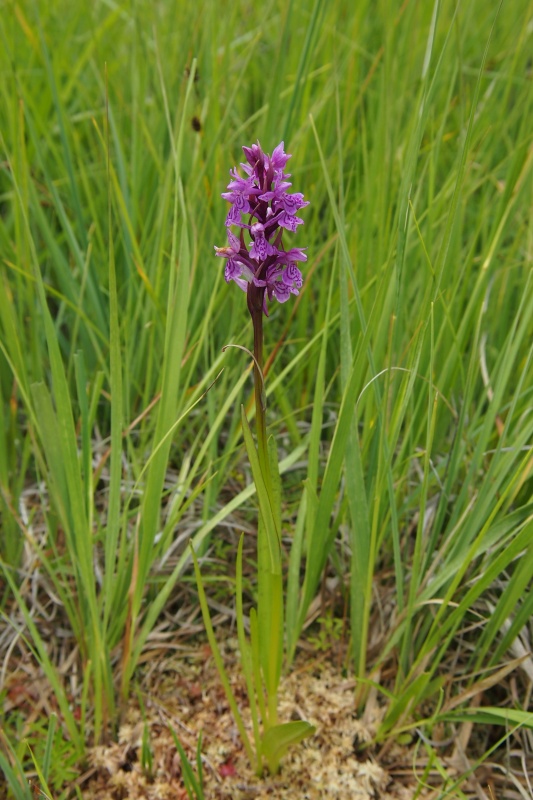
[0,0,533,797]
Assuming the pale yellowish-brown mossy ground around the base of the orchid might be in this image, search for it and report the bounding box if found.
[78,640,431,800]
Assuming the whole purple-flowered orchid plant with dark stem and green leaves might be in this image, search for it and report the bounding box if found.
[193,142,314,774]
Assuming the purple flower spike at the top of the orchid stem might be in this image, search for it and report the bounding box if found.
[215,142,309,313]
